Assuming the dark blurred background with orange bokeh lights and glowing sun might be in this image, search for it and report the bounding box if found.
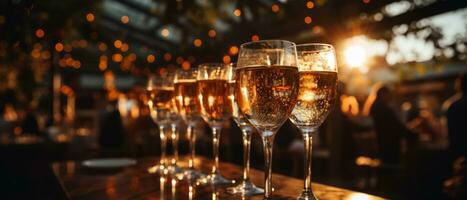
[0,0,467,199]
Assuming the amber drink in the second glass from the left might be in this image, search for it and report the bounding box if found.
[174,80,199,122]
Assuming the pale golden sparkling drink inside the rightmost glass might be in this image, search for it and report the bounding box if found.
[290,71,337,128]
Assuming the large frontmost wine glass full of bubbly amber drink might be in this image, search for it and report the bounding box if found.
[235,40,299,199]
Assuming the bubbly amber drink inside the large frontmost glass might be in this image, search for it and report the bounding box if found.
[235,66,299,132]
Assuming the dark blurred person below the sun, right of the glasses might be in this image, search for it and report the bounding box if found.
[364,84,415,164]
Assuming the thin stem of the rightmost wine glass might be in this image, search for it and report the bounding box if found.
[301,129,314,196]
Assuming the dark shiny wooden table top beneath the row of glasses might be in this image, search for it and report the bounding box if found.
[52,157,382,200]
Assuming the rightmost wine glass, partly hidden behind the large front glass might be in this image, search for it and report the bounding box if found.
[290,44,337,199]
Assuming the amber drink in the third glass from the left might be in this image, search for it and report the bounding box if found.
[197,80,233,125]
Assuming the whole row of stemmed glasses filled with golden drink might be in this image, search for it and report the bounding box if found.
[147,40,337,199]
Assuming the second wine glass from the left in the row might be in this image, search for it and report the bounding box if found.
[174,69,203,180]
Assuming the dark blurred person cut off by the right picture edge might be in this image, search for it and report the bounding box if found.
[446,73,467,157]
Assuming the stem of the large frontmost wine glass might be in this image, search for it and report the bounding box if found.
[262,131,274,199]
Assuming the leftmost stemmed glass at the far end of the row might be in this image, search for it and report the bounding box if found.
[146,73,173,173]
